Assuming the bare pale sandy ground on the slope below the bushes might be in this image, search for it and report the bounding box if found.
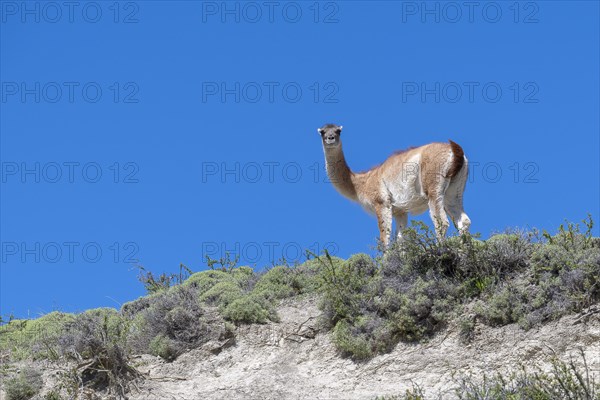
[0,298,600,400]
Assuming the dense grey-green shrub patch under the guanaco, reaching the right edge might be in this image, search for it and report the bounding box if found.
[320,218,600,359]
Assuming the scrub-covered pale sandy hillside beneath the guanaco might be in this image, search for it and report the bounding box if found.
[0,219,600,400]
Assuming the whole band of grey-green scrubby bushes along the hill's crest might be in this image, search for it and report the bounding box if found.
[0,218,600,399]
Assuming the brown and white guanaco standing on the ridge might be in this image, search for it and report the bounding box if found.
[318,124,471,247]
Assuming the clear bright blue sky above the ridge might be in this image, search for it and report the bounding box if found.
[0,1,600,317]
